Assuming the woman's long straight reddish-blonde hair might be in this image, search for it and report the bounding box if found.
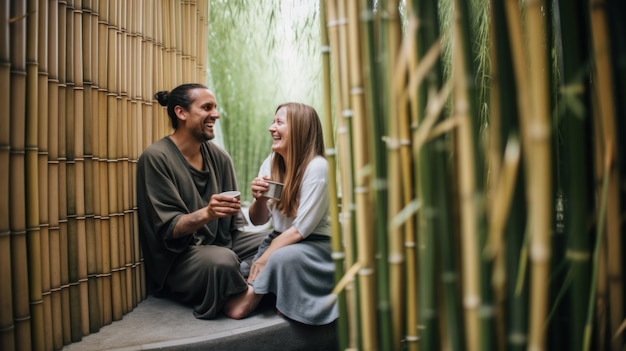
[271,102,324,217]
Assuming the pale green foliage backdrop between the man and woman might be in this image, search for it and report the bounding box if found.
[207,0,322,202]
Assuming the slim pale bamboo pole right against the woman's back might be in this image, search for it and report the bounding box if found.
[320,1,349,350]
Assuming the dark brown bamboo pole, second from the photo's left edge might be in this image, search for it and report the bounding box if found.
[8,0,31,349]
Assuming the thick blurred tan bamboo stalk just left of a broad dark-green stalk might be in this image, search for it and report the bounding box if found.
[523,1,552,350]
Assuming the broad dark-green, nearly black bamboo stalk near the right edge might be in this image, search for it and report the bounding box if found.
[558,2,593,350]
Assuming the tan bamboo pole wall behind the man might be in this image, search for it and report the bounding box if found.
[0,0,209,350]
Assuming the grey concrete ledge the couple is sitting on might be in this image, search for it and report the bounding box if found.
[63,296,337,351]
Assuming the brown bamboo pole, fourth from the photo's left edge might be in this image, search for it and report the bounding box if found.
[37,1,53,350]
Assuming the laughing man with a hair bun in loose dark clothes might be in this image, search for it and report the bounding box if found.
[137,84,266,319]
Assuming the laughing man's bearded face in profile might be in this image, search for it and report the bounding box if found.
[185,88,220,142]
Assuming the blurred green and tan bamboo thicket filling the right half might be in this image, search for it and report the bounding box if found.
[320,0,626,350]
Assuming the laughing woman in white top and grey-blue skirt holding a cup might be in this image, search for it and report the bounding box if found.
[225,103,338,325]
